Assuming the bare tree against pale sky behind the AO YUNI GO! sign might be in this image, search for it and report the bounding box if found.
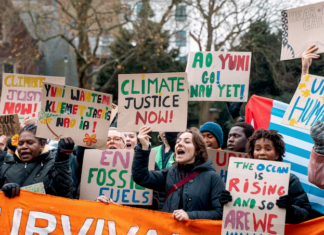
[187,0,296,125]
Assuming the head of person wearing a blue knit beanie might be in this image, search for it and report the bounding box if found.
[199,122,223,150]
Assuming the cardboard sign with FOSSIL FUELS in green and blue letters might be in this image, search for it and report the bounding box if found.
[80,149,155,205]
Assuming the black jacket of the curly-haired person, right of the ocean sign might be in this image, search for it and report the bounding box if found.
[286,173,312,224]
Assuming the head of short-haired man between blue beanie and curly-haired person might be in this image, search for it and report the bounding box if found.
[227,122,254,153]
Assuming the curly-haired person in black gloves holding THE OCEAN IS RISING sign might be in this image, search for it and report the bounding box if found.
[221,129,312,224]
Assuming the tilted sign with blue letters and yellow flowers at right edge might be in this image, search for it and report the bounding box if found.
[281,74,324,130]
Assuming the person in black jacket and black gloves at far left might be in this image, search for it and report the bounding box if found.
[0,125,74,198]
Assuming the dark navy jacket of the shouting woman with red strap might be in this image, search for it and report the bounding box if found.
[132,144,225,220]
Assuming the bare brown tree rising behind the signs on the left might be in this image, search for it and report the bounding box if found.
[6,0,180,91]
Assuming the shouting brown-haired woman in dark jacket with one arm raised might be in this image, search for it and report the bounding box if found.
[132,126,224,221]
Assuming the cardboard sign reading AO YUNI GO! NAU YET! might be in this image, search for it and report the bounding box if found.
[186,51,251,102]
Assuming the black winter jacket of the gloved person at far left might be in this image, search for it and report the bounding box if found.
[0,149,74,197]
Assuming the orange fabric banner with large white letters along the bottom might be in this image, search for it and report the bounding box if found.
[0,191,324,235]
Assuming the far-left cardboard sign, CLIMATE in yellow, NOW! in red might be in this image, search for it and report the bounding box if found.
[0,73,65,119]
